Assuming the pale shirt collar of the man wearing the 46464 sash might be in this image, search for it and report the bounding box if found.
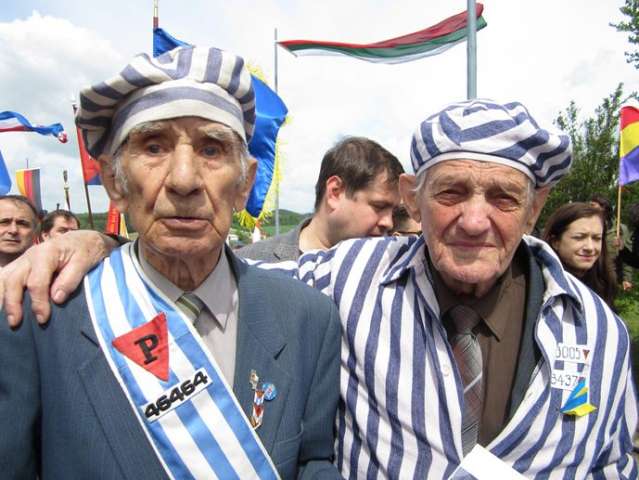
[135,244,238,330]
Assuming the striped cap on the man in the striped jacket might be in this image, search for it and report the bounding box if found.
[410,99,572,187]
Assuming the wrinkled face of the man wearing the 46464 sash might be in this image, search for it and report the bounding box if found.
[105,117,255,266]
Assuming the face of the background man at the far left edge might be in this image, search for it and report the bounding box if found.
[0,200,35,255]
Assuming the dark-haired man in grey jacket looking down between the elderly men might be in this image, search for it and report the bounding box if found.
[237,137,404,262]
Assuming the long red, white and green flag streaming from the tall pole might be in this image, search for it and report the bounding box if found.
[278,3,486,63]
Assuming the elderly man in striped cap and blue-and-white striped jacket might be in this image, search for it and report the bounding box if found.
[5,100,637,479]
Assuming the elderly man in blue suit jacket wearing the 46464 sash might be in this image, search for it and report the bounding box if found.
[0,47,340,480]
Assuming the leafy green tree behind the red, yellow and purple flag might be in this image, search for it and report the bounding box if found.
[539,83,639,225]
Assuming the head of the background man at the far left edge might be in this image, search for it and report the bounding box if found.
[0,195,38,267]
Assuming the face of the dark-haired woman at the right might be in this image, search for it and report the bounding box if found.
[551,215,603,277]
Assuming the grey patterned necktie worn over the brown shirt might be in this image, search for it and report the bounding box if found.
[444,305,482,456]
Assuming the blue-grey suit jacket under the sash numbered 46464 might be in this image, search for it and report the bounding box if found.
[0,249,340,480]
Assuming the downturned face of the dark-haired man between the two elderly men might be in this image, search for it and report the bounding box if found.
[331,172,399,244]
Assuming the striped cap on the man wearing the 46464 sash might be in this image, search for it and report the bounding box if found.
[75,46,255,158]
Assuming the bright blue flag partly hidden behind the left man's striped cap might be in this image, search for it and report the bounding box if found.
[153,28,288,227]
